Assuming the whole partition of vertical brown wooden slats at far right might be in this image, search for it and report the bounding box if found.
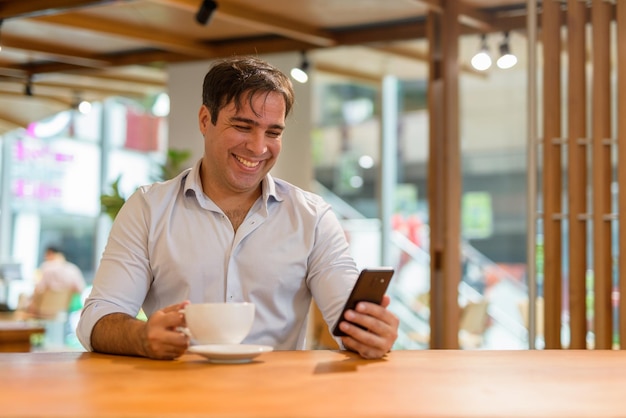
[541,0,626,349]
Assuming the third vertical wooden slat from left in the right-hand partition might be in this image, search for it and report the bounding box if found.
[591,0,613,349]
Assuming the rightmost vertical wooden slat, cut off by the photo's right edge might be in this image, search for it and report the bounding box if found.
[616,1,626,350]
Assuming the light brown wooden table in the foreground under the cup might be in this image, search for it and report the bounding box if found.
[0,350,626,418]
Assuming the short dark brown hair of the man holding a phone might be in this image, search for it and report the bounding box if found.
[202,57,294,125]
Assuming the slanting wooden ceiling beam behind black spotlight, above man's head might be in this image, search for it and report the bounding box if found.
[151,0,337,47]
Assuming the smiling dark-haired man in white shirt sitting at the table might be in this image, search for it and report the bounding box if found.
[77,57,398,359]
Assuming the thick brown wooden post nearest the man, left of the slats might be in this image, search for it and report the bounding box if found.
[428,0,462,348]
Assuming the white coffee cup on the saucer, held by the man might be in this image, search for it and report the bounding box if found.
[181,302,254,344]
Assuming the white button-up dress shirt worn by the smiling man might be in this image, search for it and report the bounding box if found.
[77,162,358,350]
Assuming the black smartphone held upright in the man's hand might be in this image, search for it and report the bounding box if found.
[333,267,394,337]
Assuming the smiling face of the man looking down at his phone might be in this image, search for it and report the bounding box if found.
[199,93,285,198]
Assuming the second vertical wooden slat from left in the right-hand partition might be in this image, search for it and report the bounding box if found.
[567,0,587,349]
